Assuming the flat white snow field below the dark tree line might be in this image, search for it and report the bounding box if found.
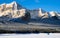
[0,33,60,38]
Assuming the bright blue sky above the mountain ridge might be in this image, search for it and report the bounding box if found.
[0,0,60,12]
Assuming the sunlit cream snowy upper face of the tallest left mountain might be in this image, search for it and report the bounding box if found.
[0,1,26,18]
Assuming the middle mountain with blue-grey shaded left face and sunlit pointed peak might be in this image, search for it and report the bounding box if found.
[30,8,48,18]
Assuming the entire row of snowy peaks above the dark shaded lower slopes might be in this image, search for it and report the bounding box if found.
[0,1,57,18]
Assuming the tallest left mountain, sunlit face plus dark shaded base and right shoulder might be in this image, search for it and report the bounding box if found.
[0,1,30,22]
